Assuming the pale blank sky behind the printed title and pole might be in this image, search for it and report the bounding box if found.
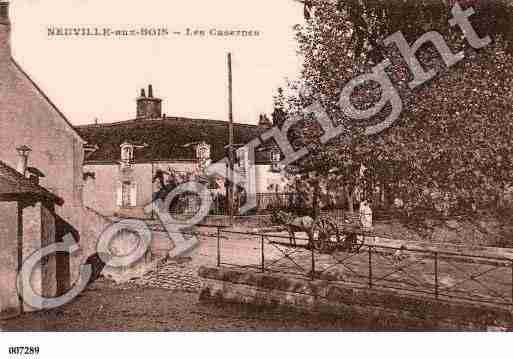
[11,0,303,125]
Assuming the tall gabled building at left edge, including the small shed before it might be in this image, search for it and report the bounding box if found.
[0,2,108,318]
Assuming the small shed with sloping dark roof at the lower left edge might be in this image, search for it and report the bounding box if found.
[0,161,70,317]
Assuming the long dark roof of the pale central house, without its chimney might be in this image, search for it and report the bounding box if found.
[76,117,268,163]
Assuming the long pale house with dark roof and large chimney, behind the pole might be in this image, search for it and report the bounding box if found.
[76,85,283,217]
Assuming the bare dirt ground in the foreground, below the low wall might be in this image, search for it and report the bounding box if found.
[0,280,436,331]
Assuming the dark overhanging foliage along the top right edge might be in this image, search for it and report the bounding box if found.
[304,0,513,60]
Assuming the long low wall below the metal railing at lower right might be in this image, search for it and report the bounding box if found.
[199,267,513,330]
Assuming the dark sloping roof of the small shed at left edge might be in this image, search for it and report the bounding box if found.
[0,161,64,205]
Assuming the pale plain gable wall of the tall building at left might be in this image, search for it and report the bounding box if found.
[0,58,97,300]
